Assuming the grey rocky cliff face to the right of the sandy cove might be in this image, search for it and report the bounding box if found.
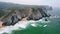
[29,8,50,20]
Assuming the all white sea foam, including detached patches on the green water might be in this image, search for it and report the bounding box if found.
[0,20,47,34]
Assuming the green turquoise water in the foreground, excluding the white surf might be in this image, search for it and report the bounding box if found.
[11,18,60,34]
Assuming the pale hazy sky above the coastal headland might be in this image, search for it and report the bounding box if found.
[0,0,60,7]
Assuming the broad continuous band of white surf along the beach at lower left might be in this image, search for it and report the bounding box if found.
[0,21,34,34]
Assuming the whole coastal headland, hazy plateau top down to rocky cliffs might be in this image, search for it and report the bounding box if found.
[0,2,52,25]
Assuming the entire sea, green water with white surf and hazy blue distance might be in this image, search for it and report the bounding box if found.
[0,8,60,34]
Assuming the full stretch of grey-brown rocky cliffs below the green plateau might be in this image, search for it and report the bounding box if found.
[1,8,50,26]
